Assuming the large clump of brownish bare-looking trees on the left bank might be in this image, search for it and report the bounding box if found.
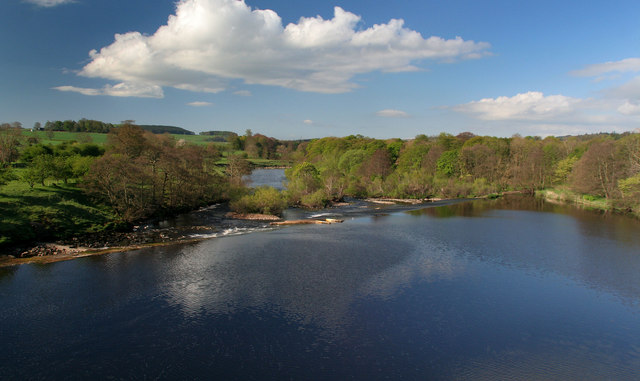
[84,124,224,222]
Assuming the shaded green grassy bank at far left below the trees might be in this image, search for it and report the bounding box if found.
[0,181,115,247]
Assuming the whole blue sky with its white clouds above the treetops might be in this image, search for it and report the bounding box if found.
[0,0,640,139]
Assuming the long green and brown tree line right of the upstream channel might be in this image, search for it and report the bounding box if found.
[286,132,640,210]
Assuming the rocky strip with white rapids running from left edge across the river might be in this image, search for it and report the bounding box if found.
[0,193,496,267]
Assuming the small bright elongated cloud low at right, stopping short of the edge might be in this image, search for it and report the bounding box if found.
[452,91,586,120]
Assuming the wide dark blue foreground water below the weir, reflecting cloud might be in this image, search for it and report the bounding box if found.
[0,171,640,380]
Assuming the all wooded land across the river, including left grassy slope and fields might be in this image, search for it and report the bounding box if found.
[0,120,640,245]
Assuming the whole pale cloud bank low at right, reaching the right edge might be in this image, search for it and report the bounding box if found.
[447,58,640,136]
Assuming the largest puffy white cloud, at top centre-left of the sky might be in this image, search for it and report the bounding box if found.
[60,0,489,93]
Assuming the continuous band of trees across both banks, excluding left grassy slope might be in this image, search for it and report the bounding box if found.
[0,122,640,227]
